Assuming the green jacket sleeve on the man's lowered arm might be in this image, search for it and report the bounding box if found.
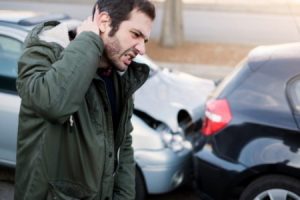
[113,112,135,200]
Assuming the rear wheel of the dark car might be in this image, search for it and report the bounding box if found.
[240,175,300,200]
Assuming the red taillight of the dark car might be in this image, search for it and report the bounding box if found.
[201,99,232,136]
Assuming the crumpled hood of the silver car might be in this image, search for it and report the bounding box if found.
[135,56,215,132]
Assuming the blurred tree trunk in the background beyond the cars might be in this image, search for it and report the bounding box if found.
[160,0,184,47]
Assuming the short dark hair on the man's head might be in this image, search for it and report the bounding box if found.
[93,0,155,36]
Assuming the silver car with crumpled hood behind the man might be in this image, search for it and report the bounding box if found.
[0,11,214,200]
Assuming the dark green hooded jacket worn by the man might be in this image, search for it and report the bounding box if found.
[15,22,149,200]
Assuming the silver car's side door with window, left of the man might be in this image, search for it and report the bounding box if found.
[0,30,23,166]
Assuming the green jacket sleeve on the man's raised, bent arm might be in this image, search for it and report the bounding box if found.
[17,32,103,123]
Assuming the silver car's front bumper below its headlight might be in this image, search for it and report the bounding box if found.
[135,148,192,194]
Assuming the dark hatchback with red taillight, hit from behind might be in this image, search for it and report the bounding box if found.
[194,43,300,200]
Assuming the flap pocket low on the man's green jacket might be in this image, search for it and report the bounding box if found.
[47,181,96,200]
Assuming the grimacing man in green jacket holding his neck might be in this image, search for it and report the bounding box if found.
[15,0,155,200]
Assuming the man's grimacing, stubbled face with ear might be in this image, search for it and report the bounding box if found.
[101,9,153,71]
